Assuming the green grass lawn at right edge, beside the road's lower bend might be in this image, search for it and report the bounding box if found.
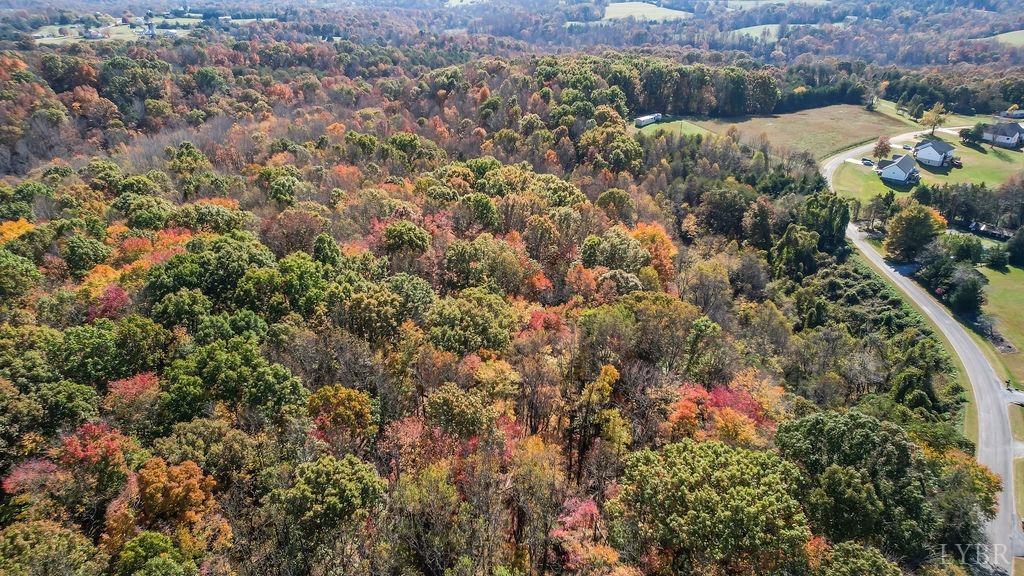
[979,266,1024,385]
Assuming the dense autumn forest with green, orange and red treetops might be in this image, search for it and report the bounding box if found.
[0,2,1007,576]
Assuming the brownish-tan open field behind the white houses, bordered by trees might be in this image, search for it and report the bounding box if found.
[694,105,906,159]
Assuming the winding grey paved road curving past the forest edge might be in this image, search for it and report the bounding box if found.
[821,128,1024,574]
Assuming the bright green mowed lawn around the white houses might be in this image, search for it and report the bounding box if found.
[834,133,1024,203]
